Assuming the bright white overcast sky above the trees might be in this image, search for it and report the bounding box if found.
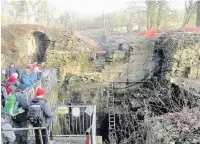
[49,0,184,16]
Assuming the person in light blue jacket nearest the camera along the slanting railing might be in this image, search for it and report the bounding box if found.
[21,69,33,88]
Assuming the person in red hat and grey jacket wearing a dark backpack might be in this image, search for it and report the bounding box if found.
[29,88,53,144]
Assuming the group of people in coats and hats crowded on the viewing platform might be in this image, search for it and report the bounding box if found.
[1,62,53,144]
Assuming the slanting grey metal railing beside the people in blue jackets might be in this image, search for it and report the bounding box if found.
[22,69,57,101]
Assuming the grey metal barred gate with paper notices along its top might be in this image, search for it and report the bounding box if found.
[52,105,96,144]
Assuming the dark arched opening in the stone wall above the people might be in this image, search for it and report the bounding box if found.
[33,32,51,63]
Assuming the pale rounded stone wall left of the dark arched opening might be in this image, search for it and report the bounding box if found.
[1,25,50,68]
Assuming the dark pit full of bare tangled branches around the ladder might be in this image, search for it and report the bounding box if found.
[98,80,198,144]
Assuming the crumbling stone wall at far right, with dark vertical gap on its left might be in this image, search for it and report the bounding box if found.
[154,33,200,79]
